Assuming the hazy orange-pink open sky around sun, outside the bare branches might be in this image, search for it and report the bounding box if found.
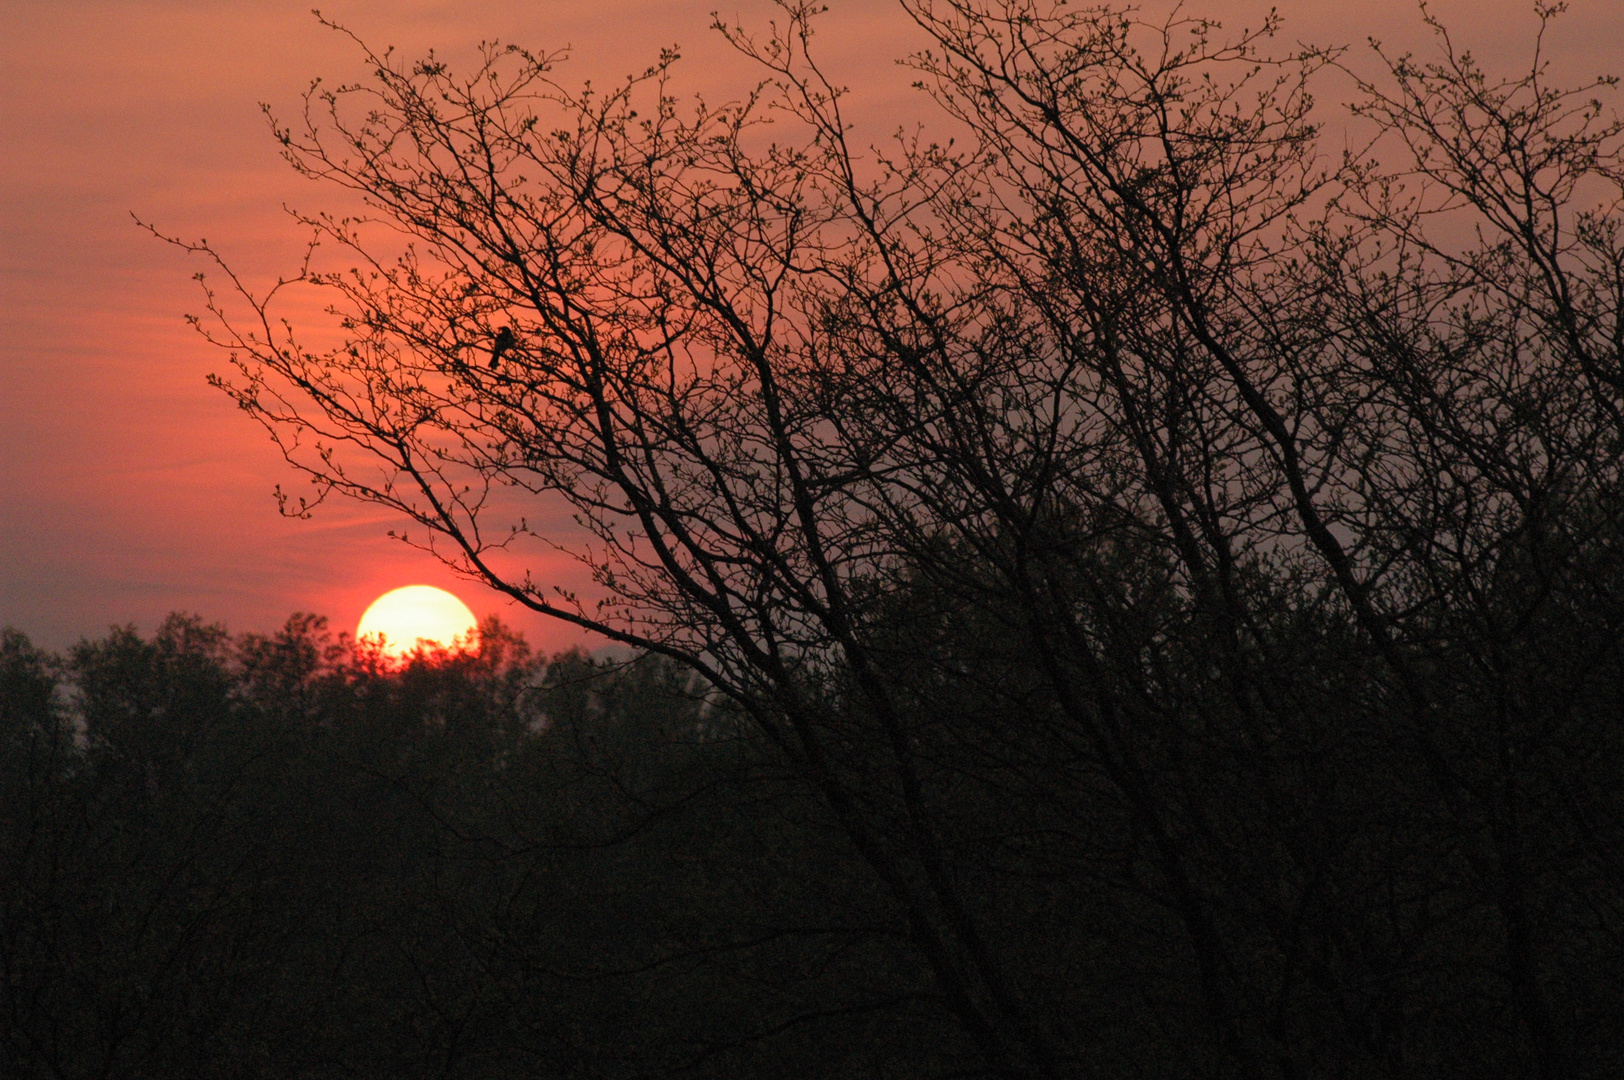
[0,0,1624,650]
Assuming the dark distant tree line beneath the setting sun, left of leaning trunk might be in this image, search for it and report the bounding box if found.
[0,617,963,1080]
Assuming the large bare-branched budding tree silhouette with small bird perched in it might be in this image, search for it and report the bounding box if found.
[107,0,1624,1080]
